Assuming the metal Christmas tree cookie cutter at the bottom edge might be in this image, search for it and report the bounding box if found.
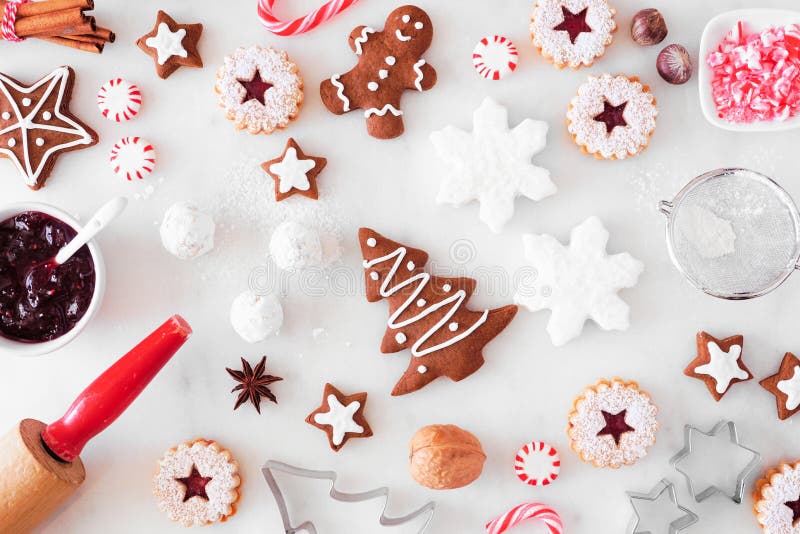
[261,460,436,534]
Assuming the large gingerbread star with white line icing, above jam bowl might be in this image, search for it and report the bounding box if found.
[0,67,97,190]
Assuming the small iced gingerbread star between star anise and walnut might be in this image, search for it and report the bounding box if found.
[306,384,372,452]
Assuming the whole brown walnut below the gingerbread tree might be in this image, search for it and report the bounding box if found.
[410,425,486,490]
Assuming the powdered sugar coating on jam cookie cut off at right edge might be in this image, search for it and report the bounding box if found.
[755,464,800,534]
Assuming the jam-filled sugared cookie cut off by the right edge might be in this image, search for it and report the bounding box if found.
[753,461,800,534]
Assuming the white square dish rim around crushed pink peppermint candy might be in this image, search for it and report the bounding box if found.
[697,9,800,132]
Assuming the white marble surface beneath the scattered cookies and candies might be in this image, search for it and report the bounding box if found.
[0,0,800,534]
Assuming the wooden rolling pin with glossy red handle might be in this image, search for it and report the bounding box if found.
[0,315,192,534]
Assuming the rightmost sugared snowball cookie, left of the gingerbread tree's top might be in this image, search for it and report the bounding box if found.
[269,221,323,271]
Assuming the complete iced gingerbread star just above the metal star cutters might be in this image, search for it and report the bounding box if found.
[683,332,753,402]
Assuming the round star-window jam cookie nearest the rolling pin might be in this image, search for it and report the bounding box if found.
[153,439,241,527]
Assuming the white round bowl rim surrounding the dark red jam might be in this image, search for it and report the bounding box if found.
[0,202,106,356]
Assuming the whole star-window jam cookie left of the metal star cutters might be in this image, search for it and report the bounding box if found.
[567,378,659,469]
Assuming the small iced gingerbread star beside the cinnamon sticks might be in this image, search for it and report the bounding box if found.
[136,11,203,79]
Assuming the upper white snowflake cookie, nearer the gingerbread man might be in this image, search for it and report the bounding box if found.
[431,98,556,232]
